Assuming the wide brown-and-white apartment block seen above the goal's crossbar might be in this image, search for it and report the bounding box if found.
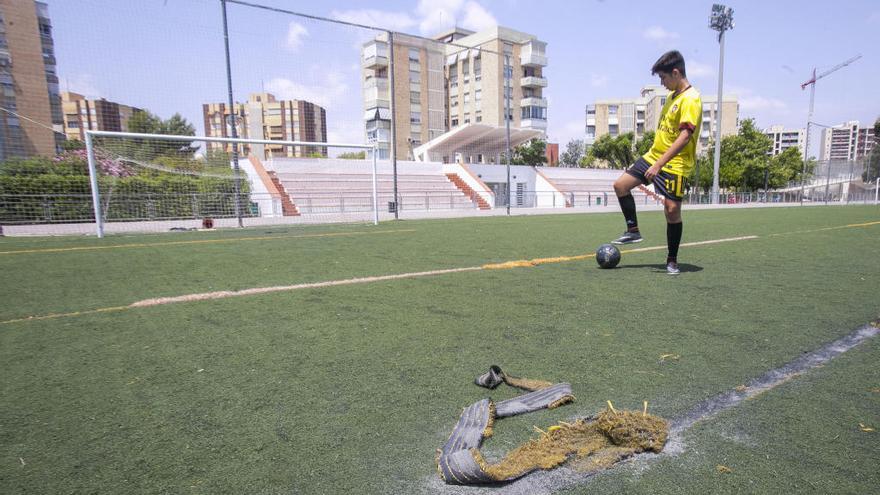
[202,93,327,158]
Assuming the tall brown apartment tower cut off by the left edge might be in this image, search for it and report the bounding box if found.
[0,0,64,160]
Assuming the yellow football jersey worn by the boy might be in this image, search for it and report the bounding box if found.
[643,87,703,176]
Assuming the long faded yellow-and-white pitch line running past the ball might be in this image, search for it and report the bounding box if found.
[0,222,880,325]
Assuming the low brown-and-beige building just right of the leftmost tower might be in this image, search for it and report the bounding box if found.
[61,91,142,141]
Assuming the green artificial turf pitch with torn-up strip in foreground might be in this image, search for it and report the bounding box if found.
[0,206,880,494]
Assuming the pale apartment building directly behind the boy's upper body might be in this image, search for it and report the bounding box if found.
[585,86,739,153]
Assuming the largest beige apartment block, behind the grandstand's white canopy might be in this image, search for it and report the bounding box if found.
[362,26,547,159]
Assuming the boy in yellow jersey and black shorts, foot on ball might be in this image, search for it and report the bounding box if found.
[612,50,703,275]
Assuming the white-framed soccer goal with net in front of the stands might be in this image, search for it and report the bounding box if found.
[81,131,379,237]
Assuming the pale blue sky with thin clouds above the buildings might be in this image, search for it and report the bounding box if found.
[46,0,880,155]
